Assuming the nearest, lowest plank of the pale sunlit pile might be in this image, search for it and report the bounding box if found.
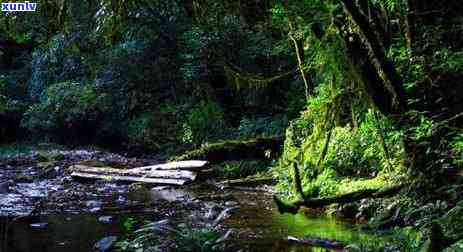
[71,172,189,185]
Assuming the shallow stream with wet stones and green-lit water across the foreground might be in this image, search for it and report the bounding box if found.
[0,149,388,252]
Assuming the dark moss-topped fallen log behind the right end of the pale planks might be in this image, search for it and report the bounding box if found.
[173,137,284,163]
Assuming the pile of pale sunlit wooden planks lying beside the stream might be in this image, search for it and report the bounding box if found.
[70,160,207,185]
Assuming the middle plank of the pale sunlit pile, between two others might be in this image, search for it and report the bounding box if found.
[70,165,197,180]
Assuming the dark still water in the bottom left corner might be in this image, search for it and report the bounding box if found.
[0,214,123,252]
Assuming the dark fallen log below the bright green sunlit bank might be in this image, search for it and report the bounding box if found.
[273,184,405,214]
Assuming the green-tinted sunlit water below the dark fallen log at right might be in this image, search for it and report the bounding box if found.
[225,192,382,251]
